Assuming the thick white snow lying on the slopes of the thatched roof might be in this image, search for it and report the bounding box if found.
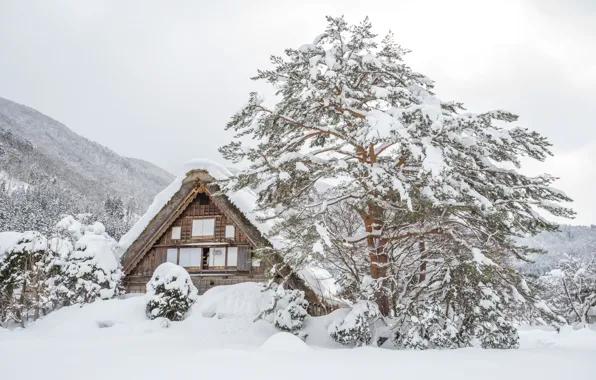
[118,158,281,257]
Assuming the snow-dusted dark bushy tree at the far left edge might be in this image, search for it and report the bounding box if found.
[0,231,57,327]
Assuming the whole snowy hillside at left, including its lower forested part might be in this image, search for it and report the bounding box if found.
[0,98,173,237]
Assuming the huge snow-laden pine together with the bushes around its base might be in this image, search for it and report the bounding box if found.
[220,17,574,348]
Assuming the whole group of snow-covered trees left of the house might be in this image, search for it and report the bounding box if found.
[0,215,124,327]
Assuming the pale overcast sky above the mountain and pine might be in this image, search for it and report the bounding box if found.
[0,0,596,224]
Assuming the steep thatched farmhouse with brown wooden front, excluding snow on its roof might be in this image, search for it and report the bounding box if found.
[122,170,325,307]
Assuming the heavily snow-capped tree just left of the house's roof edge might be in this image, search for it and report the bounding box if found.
[62,223,124,303]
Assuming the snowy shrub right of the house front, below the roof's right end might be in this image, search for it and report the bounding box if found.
[257,283,308,338]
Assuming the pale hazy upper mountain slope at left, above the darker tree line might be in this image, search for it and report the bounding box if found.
[0,98,174,209]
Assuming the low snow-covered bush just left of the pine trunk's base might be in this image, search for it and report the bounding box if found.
[328,301,381,346]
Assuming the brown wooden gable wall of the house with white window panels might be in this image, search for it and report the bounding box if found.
[123,172,264,293]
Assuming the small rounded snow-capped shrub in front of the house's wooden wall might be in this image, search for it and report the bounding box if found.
[146,263,198,321]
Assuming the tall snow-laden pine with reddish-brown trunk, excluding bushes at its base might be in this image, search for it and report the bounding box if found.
[220,17,573,330]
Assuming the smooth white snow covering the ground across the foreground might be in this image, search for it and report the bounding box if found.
[0,284,596,380]
